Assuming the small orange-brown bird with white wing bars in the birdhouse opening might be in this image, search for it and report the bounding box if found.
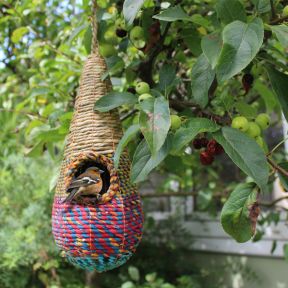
[62,166,104,203]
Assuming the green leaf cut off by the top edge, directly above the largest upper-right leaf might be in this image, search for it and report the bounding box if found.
[216,0,247,24]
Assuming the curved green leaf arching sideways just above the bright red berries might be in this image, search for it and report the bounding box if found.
[172,118,220,153]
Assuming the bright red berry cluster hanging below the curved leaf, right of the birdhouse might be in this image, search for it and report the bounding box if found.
[193,137,224,165]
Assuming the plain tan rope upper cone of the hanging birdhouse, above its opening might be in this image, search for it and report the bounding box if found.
[56,54,122,196]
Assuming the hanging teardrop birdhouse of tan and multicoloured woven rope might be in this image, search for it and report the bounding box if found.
[52,2,143,272]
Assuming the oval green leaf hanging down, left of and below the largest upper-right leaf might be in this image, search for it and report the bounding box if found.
[191,54,215,108]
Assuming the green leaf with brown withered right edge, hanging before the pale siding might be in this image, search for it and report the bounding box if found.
[221,183,259,243]
